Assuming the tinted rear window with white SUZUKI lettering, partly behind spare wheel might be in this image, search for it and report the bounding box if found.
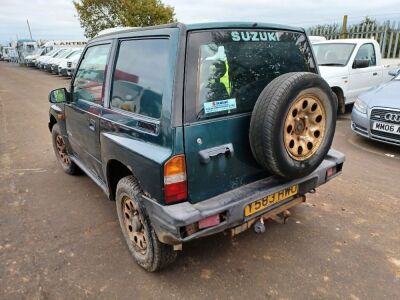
[186,30,316,120]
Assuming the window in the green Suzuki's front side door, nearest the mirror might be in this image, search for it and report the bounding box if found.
[73,44,111,104]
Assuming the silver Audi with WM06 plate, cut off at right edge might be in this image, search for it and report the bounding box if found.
[351,69,400,146]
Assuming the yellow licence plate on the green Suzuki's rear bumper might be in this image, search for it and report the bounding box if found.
[244,184,299,217]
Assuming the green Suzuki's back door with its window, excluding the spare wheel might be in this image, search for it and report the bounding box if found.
[184,29,316,202]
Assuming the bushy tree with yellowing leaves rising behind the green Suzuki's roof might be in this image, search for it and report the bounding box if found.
[73,0,176,38]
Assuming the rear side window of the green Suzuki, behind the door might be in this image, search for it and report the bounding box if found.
[111,39,169,119]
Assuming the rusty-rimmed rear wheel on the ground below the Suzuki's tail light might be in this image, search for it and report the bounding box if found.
[116,176,177,272]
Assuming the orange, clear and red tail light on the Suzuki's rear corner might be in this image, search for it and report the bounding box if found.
[164,154,187,204]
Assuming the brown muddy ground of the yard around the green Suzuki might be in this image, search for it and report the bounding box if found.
[0,62,400,300]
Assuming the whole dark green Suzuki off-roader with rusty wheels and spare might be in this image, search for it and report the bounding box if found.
[49,23,344,271]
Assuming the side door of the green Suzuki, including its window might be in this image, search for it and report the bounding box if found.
[65,43,111,180]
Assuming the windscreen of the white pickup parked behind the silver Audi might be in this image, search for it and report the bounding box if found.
[313,43,356,66]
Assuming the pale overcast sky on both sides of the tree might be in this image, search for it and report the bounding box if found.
[0,0,400,44]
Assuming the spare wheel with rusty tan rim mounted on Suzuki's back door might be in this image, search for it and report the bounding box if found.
[249,72,337,178]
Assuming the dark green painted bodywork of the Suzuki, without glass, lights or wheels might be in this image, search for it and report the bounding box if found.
[50,22,312,204]
